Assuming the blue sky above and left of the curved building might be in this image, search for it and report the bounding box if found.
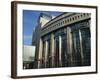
[23,10,62,45]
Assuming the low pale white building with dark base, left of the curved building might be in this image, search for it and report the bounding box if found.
[23,45,35,69]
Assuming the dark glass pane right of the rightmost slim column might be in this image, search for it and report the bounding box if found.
[81,28,91,65]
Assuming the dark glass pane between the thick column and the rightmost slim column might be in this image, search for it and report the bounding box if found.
[72,30,81,66]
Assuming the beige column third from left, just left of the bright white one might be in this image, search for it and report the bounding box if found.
[50,33,55,67]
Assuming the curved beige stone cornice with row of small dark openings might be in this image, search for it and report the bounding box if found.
[41,13,91,36]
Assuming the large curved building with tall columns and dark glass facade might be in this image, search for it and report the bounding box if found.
[32,12,91,68]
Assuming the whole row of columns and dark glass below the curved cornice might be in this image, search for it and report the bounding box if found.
[37,20,91,68]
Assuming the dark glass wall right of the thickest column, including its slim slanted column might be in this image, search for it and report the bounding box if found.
[72,27,91,66]
